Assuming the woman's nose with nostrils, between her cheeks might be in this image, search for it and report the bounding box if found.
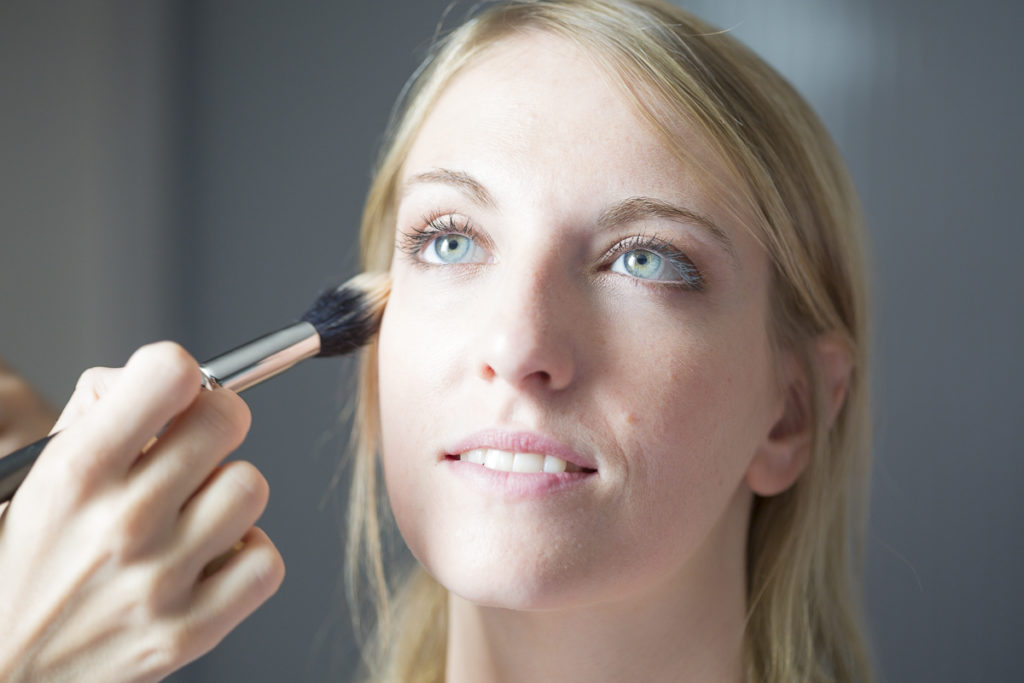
[476,272,582,391]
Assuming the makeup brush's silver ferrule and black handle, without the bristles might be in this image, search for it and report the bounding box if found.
[0,323,321,503]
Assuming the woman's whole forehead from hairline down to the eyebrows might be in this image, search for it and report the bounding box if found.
[399,31,760,270]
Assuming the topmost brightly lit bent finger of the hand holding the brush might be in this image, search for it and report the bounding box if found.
[50,342,201,480]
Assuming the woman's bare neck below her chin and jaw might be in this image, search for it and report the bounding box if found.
[445,489,749,683]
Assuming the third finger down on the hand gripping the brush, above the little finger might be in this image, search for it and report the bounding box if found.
[175,461,270,578]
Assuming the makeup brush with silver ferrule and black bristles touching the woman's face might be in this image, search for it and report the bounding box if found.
[0,272,391,503]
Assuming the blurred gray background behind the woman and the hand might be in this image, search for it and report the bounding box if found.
[0,0,1024,681]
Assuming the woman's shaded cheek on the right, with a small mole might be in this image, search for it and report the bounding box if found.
[599,317,766,524]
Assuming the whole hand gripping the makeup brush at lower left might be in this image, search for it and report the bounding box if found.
[0,343,284,682]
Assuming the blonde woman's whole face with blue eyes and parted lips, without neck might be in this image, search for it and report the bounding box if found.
[379,35,782,608]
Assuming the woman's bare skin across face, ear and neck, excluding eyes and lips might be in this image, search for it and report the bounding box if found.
[378,34,806,681]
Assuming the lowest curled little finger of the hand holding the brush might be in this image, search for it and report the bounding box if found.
[189,526,285,643]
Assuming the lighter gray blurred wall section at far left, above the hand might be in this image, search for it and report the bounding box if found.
[0,0,183,389]
